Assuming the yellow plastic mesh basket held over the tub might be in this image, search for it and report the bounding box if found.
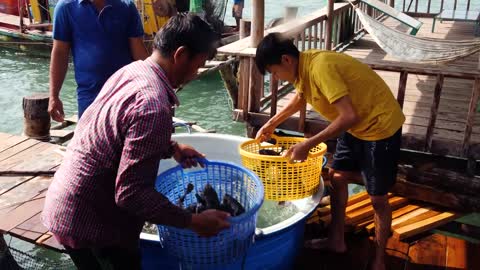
[239,135,327,201]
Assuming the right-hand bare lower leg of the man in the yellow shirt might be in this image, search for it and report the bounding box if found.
[370,195,392,270]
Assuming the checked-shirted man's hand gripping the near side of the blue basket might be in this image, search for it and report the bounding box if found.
[189,209,230,237]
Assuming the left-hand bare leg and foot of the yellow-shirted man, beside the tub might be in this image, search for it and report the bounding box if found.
[306,170,360,252]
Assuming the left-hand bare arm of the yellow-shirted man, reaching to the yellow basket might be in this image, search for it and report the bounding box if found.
[256,93,305,140]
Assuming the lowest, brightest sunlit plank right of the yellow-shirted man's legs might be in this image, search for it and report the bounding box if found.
[393,212,461,240]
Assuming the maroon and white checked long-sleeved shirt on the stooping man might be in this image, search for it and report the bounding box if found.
[42,58,191,248]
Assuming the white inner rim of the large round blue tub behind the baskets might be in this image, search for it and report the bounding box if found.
[140,133,324,241]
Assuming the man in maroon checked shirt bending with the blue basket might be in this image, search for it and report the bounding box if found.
[42,14,229,270]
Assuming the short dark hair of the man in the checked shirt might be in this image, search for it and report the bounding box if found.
[153,13,220,58]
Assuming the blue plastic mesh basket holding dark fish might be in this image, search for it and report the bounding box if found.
[155,160,264,266]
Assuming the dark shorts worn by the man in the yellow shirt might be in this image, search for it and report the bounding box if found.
[331,129,402,196]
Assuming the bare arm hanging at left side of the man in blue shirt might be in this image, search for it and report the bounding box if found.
[48,40,70,122]
